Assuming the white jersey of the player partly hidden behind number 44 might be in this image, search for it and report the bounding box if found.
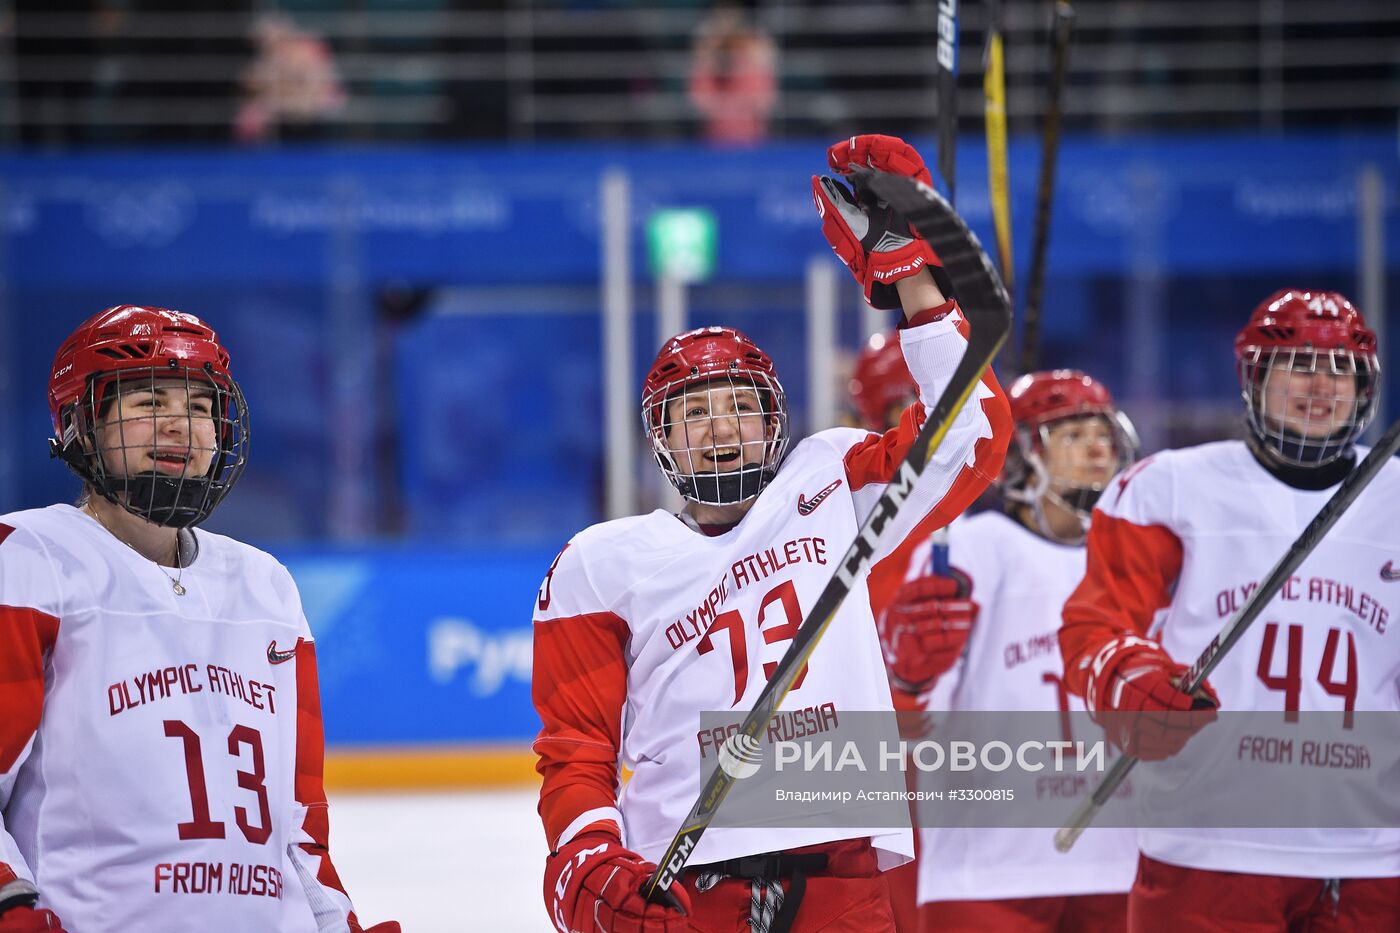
[910,511,1138,904]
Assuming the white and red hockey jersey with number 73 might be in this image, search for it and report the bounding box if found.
[533,308,1011,867]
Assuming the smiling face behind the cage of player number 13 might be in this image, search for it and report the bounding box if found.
[97,378,218,479]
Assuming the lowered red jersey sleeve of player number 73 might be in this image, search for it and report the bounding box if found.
[531,537,630,849]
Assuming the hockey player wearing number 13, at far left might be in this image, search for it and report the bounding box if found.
[0,305,399,933]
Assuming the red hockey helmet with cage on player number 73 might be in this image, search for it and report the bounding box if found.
[641,326,788,506]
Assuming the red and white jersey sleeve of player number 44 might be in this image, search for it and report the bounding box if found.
[1060,458,1183,696]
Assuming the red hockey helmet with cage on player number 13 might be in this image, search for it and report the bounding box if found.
[49,304,249,528]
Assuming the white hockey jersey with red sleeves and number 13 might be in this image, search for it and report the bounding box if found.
[0,506,358,933]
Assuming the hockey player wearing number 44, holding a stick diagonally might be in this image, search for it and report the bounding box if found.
[1060,289,1400,933]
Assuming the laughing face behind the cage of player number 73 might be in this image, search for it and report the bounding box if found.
[665,378,771,476]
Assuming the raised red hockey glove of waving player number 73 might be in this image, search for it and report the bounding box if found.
[812,136,952,308]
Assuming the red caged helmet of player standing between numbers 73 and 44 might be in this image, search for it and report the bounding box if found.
[1001,370,1138,544]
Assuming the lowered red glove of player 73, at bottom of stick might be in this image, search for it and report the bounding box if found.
[545,832,692,933]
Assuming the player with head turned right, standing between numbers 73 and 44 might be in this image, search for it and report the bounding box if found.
[879,370,1137,933]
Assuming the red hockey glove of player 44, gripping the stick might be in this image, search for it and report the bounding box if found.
[1085,635,1219,761]
